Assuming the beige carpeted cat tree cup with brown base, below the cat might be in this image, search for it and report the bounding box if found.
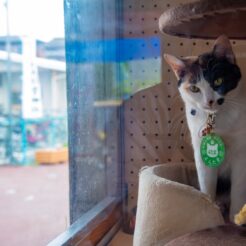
[133,163,246,246]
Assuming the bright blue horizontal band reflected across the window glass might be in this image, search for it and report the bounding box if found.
[66,36,161,63]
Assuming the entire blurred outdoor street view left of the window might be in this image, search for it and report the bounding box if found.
[0,0,69,245]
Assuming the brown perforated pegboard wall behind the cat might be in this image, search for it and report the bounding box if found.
[124,0,246,231]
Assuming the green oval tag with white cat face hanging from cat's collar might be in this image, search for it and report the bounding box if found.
[200,133,225,168]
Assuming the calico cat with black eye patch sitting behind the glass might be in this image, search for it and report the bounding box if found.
[164,35,246,221]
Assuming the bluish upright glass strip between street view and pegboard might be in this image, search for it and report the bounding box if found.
[65,1,123,221]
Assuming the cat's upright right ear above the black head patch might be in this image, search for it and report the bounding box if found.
[213,35,235,64]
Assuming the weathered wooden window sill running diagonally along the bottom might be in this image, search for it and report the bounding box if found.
[48,198,122,246]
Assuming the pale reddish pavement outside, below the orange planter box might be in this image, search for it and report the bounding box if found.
[0,164,69,246]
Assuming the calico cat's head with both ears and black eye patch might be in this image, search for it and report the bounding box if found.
[164,36,241,112]
